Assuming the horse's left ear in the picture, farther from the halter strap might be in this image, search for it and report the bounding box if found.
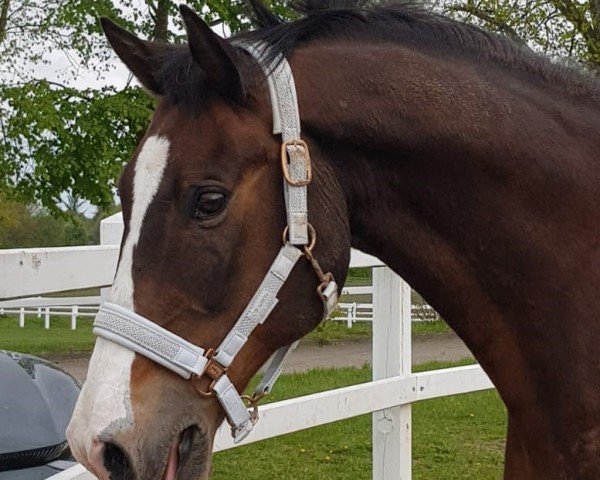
[100,17,168,95]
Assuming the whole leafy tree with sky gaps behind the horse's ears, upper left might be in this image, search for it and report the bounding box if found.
[0,0,286,214]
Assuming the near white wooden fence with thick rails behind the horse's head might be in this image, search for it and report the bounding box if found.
[0,216,493,480]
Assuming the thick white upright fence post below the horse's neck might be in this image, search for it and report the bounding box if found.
[373,267,412,480]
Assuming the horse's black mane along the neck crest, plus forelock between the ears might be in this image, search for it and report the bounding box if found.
[163,0,600,107]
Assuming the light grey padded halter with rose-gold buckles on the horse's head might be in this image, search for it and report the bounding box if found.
[94,42,338,443]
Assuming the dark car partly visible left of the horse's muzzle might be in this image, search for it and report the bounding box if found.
[0,350,81,480]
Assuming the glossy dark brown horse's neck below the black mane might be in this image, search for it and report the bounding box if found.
[292,44,600,472]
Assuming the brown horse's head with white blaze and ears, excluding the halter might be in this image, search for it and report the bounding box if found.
[68,8,350,480]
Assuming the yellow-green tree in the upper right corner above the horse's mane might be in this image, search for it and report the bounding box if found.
[436,0,600,70]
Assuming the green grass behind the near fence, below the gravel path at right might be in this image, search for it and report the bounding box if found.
[212,361,506,480]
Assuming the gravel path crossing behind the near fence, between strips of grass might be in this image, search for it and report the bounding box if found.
[50,333,472,380]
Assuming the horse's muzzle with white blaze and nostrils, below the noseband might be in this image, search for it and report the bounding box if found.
[67,339,223,480]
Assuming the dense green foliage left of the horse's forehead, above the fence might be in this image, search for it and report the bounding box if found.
[0,80,153,213]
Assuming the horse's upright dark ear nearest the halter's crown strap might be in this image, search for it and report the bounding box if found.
[179,5,244,101]
